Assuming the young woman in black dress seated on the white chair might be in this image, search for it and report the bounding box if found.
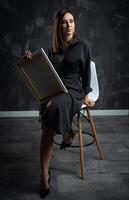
[26,10,94,198]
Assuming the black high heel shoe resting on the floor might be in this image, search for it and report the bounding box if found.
[39,171,50,199]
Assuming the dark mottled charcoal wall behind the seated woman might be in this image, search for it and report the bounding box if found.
[0,0,129,110]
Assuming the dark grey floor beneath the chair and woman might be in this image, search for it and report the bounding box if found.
[0,116,129,200]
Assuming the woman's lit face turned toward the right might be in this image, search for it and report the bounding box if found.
[61,13,75,38]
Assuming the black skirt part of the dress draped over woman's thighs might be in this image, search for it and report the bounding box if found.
[40,93,83,135]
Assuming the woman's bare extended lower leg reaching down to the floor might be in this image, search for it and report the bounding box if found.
[40,129,53,189]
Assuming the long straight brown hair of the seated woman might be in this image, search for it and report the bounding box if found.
[52,9,76,53]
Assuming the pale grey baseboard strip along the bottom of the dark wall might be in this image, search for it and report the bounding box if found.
[0,109,129,117]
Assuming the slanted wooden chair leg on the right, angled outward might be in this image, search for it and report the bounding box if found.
[86,108,104,160]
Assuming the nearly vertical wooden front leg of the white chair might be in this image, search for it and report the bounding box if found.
[77,113,85,179]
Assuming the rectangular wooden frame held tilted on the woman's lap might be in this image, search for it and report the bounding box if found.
[17,49,68,103]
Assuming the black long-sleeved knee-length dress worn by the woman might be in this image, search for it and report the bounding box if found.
[40,38,92,135]
